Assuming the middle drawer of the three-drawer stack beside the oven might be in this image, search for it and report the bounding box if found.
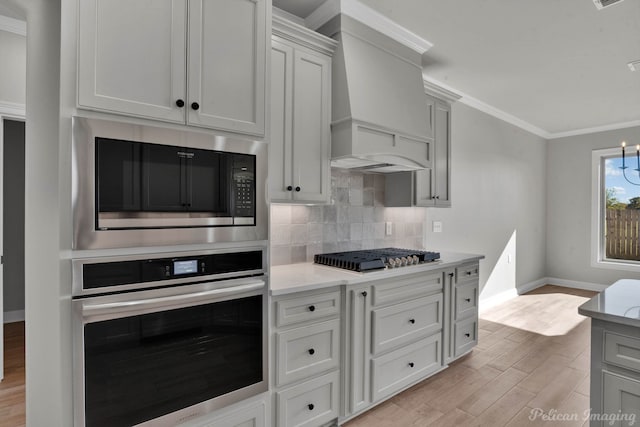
[276,319,340,385]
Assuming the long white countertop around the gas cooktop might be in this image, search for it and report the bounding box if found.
[269,252,484,295]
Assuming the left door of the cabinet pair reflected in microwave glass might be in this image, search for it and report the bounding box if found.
[142,144,187,212]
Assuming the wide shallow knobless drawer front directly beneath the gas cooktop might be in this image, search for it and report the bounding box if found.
[372,271,443,305]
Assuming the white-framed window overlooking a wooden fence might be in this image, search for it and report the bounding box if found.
[592,148,640,270]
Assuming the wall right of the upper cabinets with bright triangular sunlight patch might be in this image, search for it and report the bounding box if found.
[425,102,547,299]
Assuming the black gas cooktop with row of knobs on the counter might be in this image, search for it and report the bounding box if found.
[313,248,440,272]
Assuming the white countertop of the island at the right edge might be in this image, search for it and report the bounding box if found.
[578,279,640,327]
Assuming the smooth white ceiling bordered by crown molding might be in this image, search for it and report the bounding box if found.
[273,0,640,138]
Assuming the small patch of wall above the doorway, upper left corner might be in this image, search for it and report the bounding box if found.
[0,30,27,108]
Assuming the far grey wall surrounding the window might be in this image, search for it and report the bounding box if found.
[547,127,640,285]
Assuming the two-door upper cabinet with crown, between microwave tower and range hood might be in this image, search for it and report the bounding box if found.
[269,16,336,203]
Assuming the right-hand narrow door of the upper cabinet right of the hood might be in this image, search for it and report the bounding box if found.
[431,101,451,207]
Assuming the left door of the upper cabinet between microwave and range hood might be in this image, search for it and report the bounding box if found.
[269,38,293,201]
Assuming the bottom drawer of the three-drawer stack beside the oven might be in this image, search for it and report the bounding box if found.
[276,371,340,427]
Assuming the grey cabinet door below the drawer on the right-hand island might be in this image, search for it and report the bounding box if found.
[604,371,640,426]
